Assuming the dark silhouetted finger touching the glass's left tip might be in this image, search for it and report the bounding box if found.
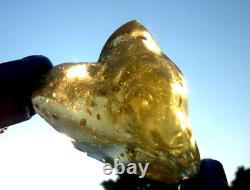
[0,56,52,128]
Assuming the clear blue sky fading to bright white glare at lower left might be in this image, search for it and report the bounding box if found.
[0,0,250,189]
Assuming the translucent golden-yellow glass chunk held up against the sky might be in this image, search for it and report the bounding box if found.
[32,21,200,183]
